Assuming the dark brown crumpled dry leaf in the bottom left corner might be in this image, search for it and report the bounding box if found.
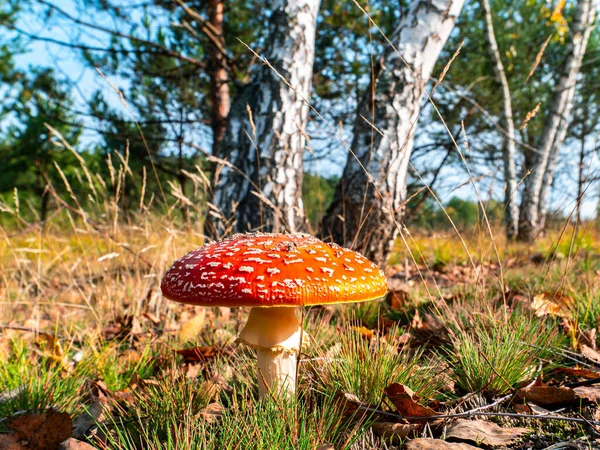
[7,409,72,450]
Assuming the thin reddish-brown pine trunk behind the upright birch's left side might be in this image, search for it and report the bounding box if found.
[208,0,230,156]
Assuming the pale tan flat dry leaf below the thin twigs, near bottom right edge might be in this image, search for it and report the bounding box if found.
[446,419,531,447]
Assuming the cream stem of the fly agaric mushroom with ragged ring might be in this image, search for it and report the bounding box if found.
[238,307,302,398]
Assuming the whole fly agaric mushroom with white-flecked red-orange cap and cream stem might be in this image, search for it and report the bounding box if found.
[161,233,387,398]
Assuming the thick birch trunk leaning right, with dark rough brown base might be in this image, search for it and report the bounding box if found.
[322,0,464,265]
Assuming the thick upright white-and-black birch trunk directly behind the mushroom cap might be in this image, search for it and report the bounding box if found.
[209,0,319,235]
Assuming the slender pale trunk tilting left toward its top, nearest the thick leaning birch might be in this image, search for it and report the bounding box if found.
[479,0,519,239]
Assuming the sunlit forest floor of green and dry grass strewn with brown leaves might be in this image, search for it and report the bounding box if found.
[0,222,600,450]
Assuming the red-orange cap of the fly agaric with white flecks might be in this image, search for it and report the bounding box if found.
[160,234,387,307]
